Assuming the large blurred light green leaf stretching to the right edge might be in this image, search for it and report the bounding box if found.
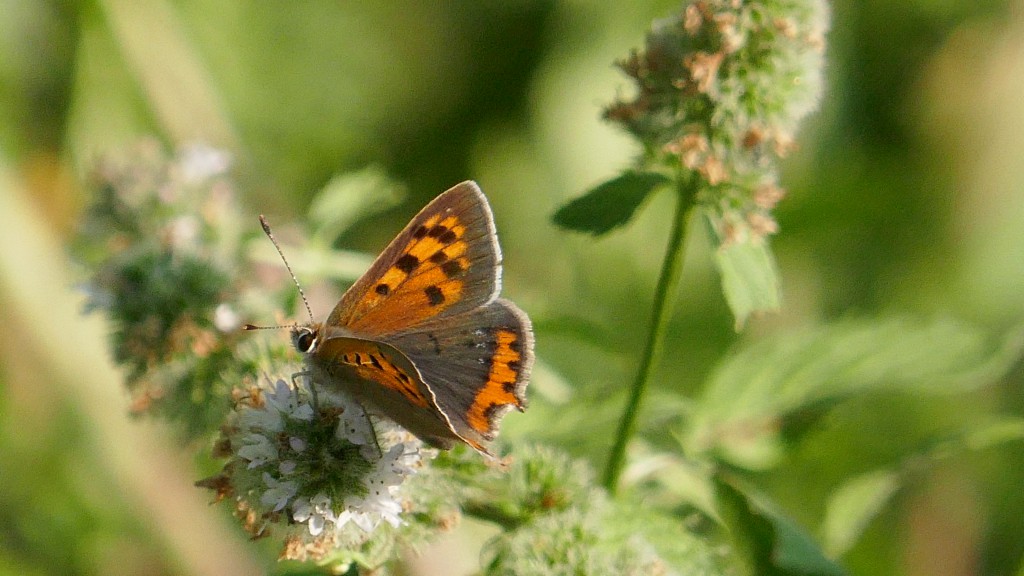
[684,318,1024,468]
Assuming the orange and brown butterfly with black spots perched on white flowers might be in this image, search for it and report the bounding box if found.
[264,181,534,454]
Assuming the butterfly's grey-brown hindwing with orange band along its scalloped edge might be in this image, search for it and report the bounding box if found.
[383,298,534,452]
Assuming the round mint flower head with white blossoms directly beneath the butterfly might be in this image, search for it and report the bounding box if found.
[200,379,426,560]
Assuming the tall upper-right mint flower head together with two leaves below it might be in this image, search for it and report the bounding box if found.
[553,0,828,332]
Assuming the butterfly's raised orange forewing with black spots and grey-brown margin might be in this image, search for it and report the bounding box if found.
[326,181,501,338]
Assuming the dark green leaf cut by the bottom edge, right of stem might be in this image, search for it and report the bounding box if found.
[715,477,846,576]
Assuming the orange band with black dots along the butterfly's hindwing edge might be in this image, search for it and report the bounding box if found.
[466,330,522,438]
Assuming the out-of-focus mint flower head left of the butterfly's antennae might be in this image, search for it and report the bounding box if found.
[73,140,253,438]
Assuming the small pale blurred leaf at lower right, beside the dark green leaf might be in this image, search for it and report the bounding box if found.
[822,469,900,557]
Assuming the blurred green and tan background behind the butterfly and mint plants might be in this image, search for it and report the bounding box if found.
[0,0,1024,575]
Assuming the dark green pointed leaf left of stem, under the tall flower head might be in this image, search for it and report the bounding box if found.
[552,171,670,236]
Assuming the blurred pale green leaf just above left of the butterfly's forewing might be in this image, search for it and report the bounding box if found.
[309,166,406,246]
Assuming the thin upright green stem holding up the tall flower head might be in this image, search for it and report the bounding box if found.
[604,179,693,494]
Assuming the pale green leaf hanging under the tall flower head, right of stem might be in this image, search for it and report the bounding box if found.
[715,240,781,330]
